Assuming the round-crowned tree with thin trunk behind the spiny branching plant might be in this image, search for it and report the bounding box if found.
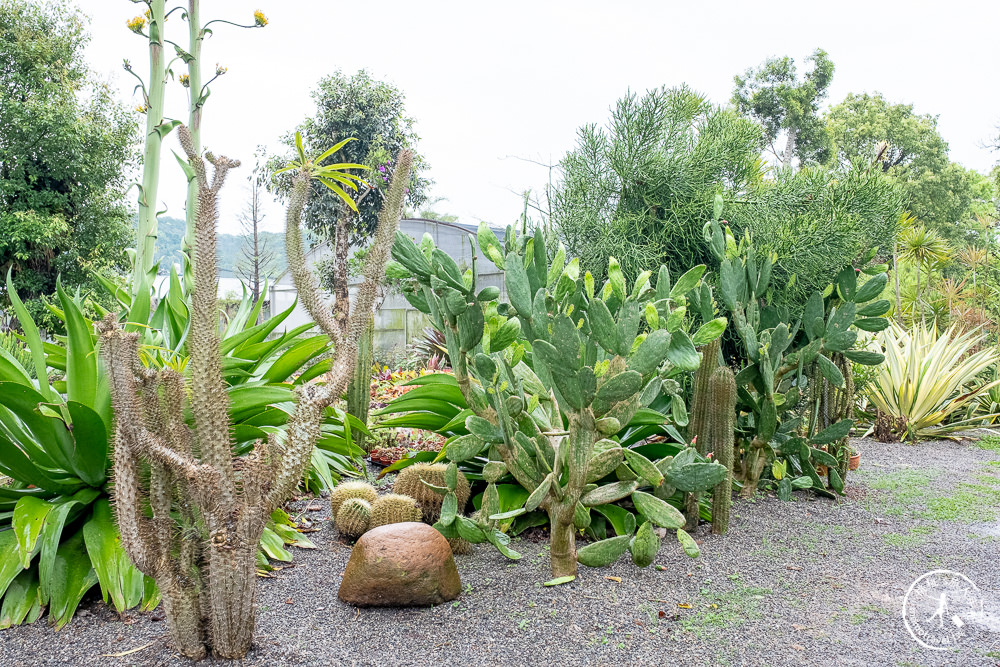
[270,70,430,332]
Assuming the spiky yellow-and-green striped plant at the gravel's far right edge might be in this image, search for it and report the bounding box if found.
[867,323,1000,440]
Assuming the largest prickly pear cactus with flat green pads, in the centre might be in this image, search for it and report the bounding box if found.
[393,225,728,577]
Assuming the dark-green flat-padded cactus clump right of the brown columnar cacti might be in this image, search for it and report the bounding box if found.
[705,196,890,498]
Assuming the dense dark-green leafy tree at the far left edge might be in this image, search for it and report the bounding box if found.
[0,0,137,325]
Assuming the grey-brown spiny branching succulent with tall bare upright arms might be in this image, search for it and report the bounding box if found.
[99,127,411,659]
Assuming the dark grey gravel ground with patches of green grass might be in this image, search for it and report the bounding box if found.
[0,440,1000,667]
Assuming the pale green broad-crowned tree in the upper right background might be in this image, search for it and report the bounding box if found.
[825,93,991,245]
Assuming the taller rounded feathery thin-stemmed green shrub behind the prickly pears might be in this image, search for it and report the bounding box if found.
[551,86,763,279]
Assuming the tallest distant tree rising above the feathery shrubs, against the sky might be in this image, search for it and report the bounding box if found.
[732,49,834,167]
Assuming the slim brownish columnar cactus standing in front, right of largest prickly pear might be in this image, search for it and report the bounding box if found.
[705,366,736,535]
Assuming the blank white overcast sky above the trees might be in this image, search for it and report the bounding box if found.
[78,0,1000,233]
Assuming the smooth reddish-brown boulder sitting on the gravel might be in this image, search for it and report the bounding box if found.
[337,522,462,607]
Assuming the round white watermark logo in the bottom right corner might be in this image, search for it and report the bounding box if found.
[903,570,983,651]
